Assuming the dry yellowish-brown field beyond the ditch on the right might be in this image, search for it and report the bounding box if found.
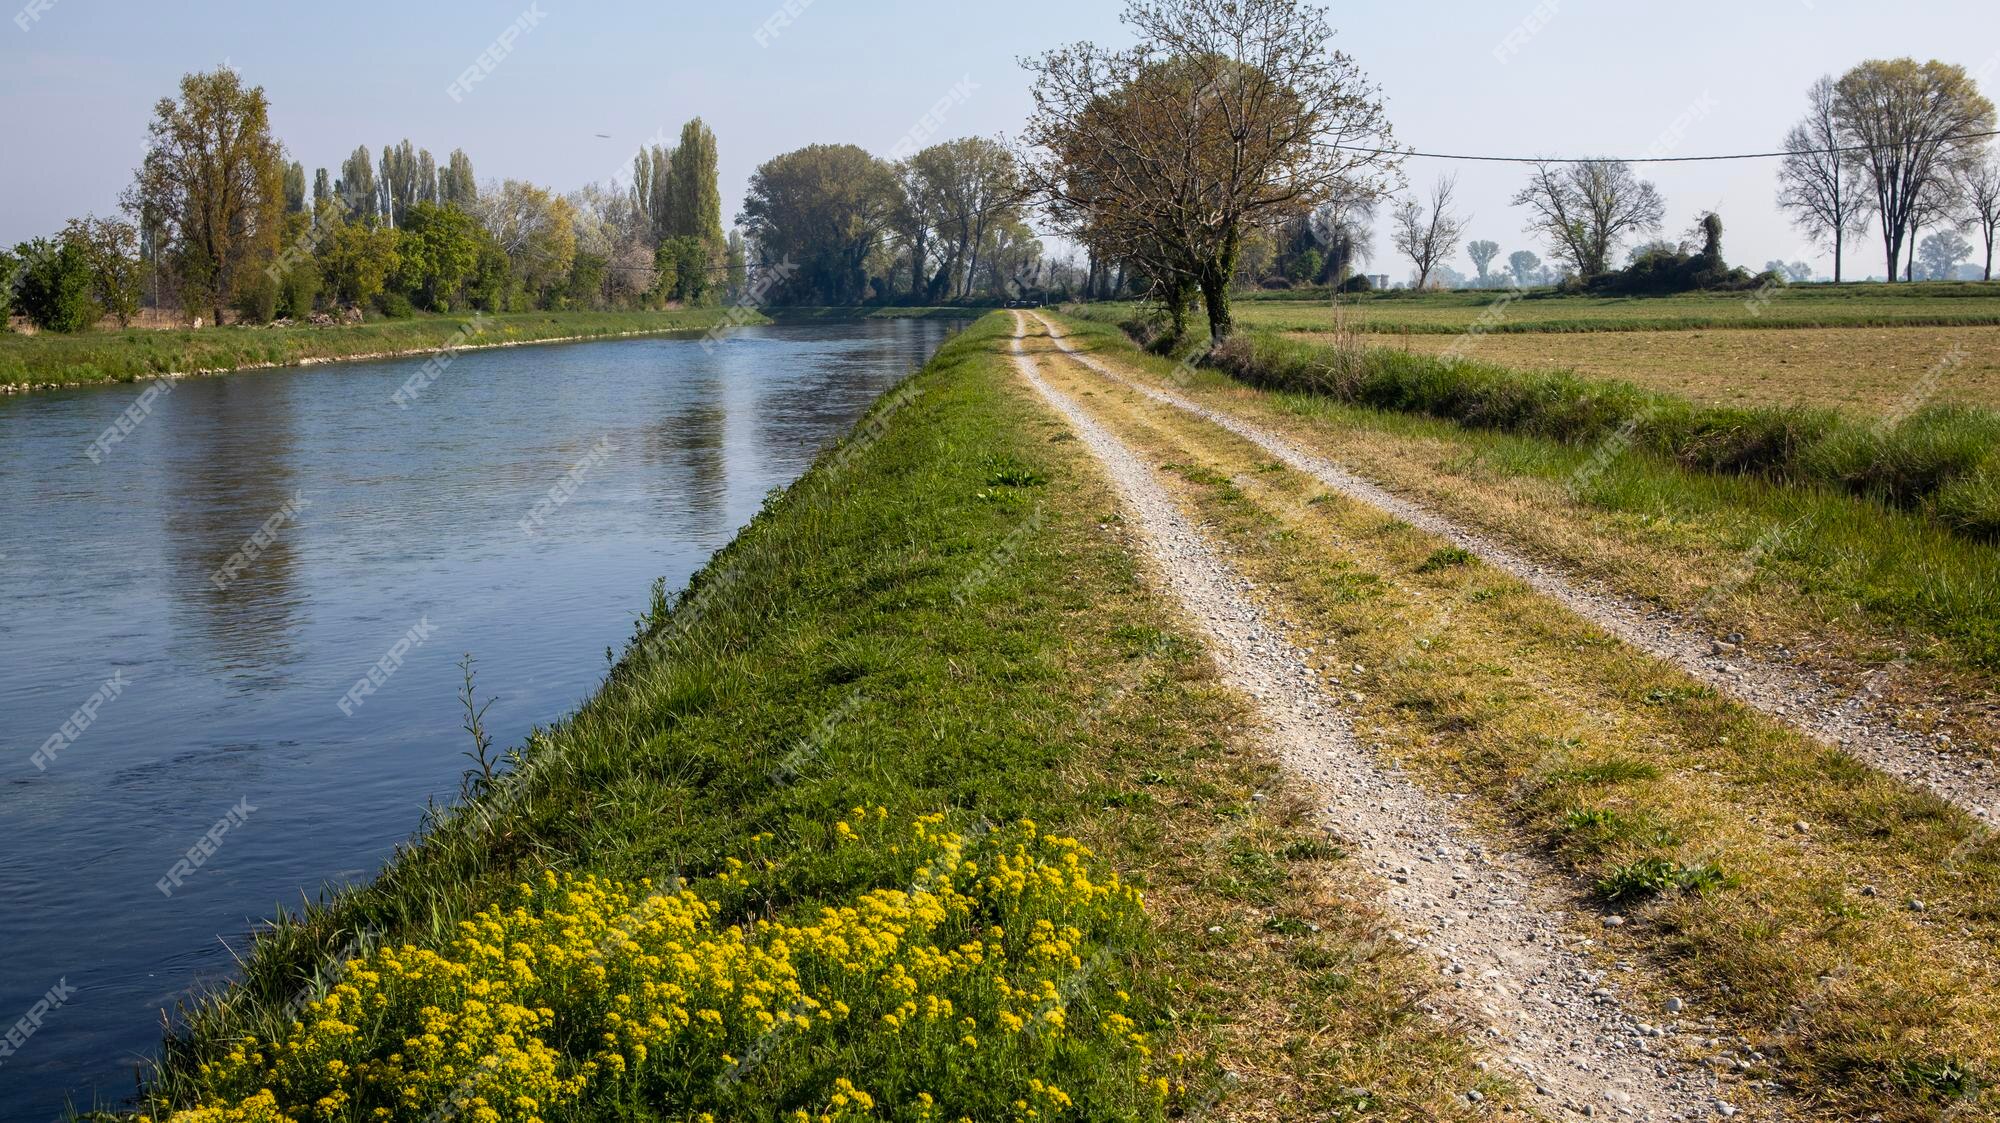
[1296,328,2000,416]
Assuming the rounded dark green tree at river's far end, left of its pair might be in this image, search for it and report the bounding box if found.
[736,144,902,304]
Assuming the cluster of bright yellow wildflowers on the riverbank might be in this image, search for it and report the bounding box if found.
[170,807,1150,1123]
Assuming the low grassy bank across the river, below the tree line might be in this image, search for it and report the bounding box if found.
[0,308,740,388]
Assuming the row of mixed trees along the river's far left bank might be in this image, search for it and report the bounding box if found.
[0,68,748,332]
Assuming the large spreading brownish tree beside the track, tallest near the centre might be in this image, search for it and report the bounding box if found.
[1024,0,1396,342]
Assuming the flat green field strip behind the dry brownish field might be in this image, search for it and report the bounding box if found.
[1200,282,2000,334]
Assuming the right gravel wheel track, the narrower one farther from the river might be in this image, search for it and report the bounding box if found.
[1036,307,2000,825]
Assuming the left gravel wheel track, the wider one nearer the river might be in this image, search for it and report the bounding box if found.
[1014,312,1736,1119]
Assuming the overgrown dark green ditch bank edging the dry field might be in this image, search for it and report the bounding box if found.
[1090,310,2000,540]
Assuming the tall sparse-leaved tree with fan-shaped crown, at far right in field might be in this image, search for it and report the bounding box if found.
[1834,58,1994,282]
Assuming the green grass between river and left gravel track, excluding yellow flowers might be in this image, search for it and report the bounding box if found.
[121,316,1508,1119]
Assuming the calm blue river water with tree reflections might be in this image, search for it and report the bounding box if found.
[0,320,956,1121]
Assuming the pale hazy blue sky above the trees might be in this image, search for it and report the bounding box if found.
[0,0,2000,276]
